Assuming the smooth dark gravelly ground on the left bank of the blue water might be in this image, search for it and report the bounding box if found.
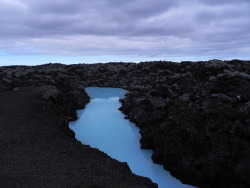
[0,86,157,188]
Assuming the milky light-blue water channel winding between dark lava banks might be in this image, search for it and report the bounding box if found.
[69,87,194,188]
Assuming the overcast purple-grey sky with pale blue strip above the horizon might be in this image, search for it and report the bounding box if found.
[0,0,250,65]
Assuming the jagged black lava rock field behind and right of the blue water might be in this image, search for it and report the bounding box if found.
[0,60,250,188]
